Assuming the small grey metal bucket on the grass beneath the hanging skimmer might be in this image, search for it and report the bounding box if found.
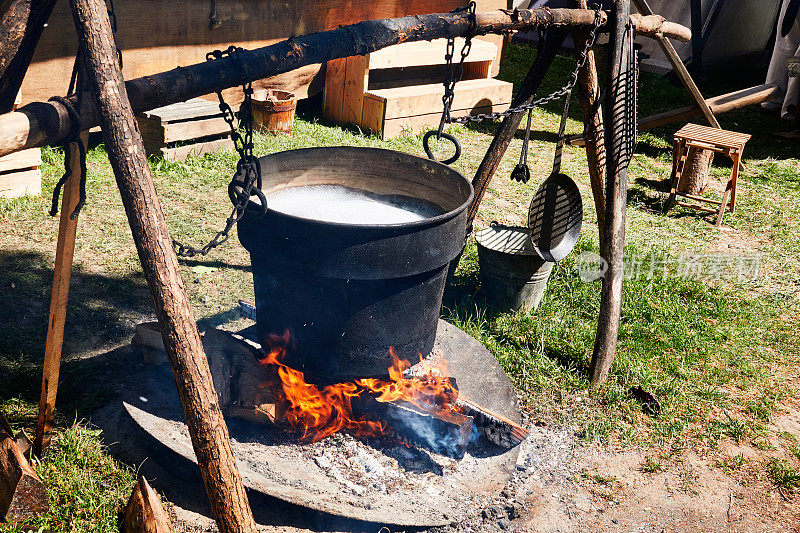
[475,223,553,311]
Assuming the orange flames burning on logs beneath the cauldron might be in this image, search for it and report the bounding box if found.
[261,331,459,442]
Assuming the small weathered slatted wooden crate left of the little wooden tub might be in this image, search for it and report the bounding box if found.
[136,98,234,161]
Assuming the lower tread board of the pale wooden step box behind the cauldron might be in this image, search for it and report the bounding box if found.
[369,78,514,120]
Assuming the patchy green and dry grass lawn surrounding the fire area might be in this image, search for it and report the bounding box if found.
[0,46,800,531]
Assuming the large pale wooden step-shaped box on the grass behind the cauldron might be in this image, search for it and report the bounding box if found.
[323,39,513,139]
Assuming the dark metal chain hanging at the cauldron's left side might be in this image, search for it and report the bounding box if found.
[172,46,267,257]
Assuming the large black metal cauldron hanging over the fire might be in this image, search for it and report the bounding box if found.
[238,147,472,380]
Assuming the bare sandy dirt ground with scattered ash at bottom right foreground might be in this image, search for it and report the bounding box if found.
[159,402,800,533]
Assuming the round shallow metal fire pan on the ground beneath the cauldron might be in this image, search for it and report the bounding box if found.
[117,321,520,527]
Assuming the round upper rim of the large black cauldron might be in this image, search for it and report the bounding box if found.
[247,146,475,230]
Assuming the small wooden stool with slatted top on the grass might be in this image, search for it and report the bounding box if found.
[665,124,750,227]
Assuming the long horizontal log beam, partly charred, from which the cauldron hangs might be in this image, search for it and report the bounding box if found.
[0,8,691,156]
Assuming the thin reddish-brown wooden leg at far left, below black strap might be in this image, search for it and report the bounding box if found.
[33,131,89,457]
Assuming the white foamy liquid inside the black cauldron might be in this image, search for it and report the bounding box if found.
[267,185,442,225]
